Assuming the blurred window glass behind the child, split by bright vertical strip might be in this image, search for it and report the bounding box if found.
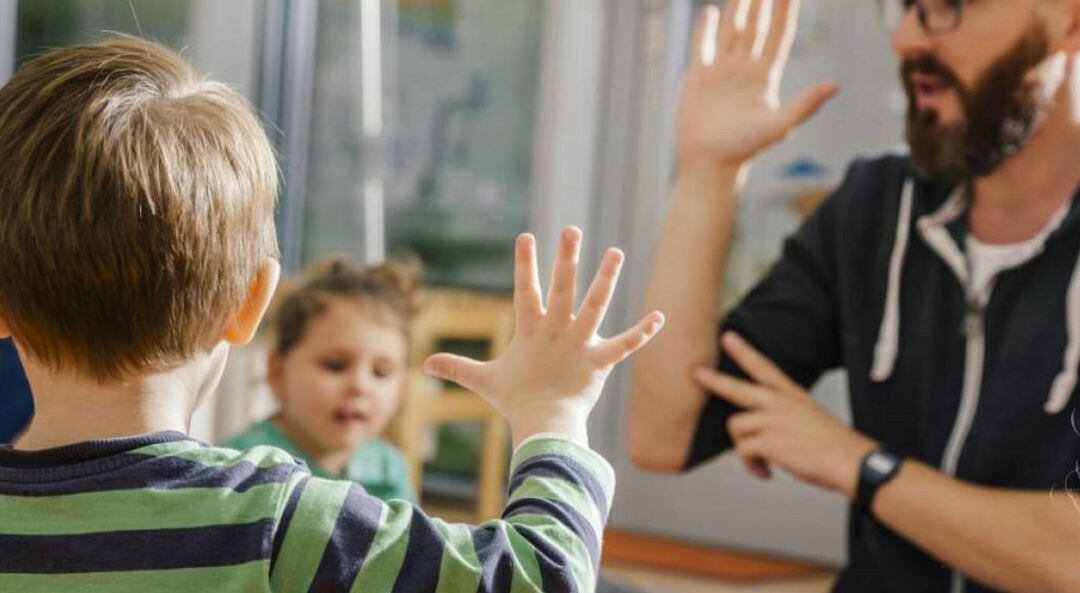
[305,0,543,289]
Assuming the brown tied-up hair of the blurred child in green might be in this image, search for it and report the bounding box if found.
[270,256,420,354]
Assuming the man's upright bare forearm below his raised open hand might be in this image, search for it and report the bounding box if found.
[630,166,741,471]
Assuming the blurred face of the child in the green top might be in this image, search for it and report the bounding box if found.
[269,298,407,454]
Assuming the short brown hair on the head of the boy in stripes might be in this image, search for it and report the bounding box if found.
[0,37,278,381]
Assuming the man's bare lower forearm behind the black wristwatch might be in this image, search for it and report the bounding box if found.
[874,461,1080,593]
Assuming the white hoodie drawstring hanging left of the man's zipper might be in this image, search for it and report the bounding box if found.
[870,178,915,382]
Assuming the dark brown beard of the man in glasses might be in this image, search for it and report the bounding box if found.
[901,26,1050,181]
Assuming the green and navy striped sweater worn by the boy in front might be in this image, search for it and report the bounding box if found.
[0,432,615,593]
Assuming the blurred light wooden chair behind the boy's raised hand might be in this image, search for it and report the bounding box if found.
[394,291,514,522]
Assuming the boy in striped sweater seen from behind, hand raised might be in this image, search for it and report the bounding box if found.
[0,38,662,593]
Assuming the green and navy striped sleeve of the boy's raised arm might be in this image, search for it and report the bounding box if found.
[270,437,615,593]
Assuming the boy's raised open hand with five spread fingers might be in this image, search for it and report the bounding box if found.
[424,228,664,445]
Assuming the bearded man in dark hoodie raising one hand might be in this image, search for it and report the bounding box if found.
[629,0,1080,593]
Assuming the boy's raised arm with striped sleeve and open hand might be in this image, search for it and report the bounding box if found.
[270,229,663,593]
